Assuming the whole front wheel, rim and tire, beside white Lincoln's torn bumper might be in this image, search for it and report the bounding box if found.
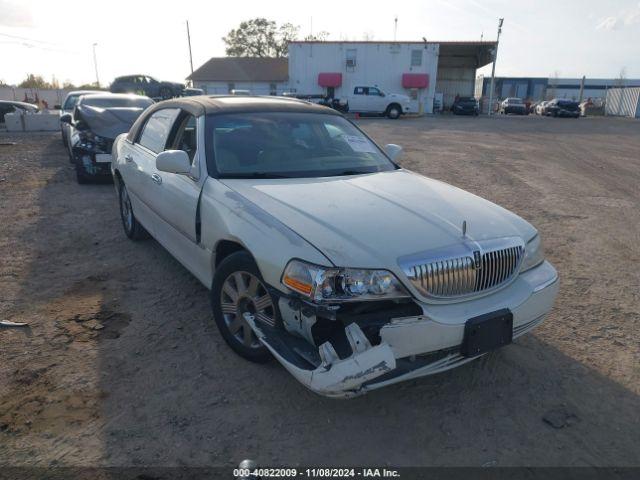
[211,251,278,363]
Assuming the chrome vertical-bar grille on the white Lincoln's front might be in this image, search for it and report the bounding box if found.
[403,244,524,298]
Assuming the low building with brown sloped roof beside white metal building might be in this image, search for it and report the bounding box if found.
[187,57,289,95]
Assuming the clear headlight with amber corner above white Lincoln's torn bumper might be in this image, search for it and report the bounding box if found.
[282,260,409,302]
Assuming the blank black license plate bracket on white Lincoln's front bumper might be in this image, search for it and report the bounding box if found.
[460,308,513,357]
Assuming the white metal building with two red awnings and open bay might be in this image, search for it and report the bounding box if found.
[289,41,495,113]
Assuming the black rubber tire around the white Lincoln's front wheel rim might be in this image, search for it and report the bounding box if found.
[211,251,272,363]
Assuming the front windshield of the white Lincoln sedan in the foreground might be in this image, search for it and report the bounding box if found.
[208,112,396,178]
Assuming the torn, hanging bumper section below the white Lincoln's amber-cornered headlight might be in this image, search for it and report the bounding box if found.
[245,314,396,398]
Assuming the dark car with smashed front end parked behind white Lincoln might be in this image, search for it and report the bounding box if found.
[60,93,154,183]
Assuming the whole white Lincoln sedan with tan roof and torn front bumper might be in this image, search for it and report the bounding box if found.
[111,96,558,397]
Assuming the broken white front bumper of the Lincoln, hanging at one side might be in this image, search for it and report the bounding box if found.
[245,262,558,398]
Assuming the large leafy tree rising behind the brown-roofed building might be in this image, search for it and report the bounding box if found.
[222,18,300,57]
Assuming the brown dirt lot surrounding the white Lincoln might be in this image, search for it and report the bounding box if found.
[0,117,640,466]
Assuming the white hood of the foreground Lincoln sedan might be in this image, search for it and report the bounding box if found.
[222,169,536,271]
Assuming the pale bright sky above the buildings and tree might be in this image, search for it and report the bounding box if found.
[0,0,640,84]
